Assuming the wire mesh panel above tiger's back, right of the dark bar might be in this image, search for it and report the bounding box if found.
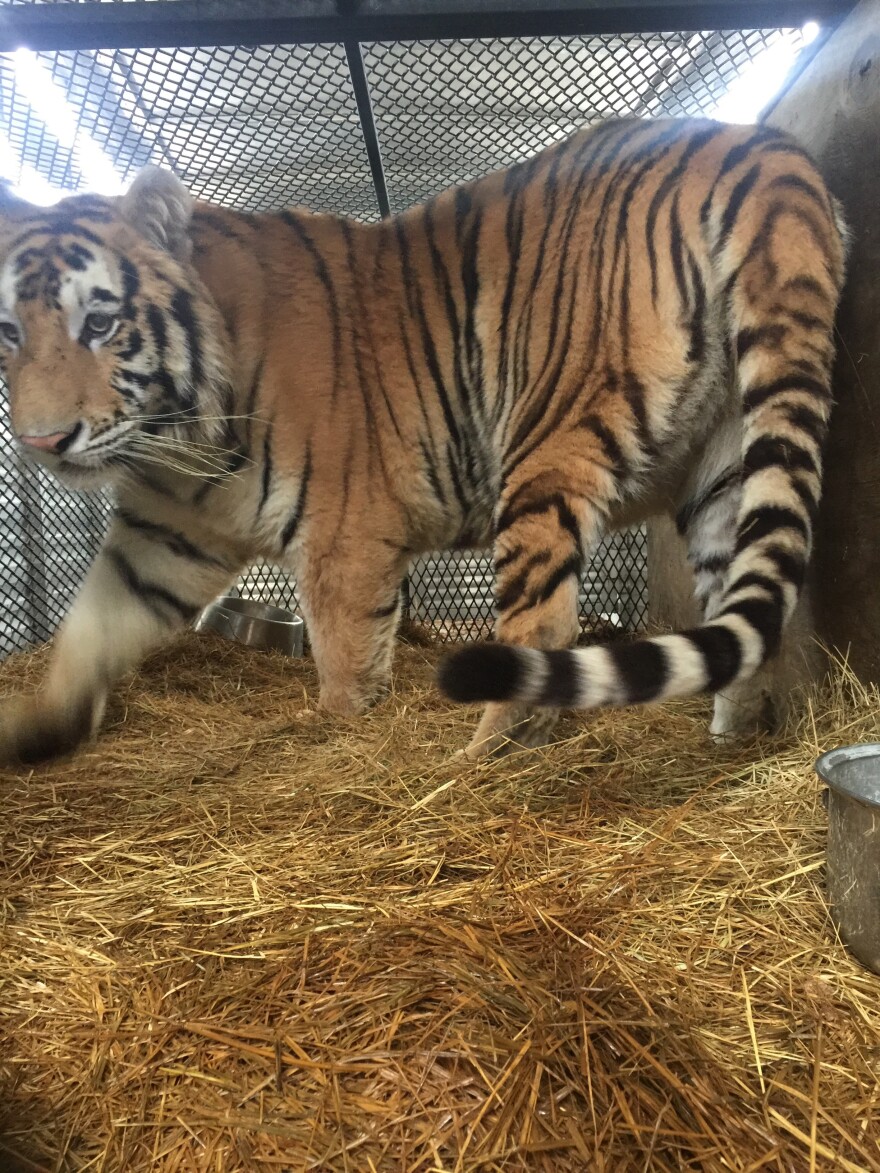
[364,29,803,211]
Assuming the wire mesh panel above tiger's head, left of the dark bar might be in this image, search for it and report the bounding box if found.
[0,42,379,219]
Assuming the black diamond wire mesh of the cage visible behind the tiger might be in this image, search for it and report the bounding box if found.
[0,0,830,656]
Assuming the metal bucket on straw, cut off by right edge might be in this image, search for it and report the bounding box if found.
[815,744,880,974]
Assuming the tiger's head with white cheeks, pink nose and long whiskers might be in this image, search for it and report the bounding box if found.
[0,168,229,488]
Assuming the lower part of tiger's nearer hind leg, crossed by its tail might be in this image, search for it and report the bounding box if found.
[463,461,598,760]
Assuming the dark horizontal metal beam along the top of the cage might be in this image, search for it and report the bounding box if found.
[0,0,854,53]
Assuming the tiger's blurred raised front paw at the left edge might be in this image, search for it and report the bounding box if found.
[0,693,103,766]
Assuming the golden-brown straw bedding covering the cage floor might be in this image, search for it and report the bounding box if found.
[0,636,880,1173]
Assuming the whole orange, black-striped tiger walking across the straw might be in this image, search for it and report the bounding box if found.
[0,118,846,762]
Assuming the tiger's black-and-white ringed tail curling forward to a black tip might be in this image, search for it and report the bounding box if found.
[439,161,846,708]
